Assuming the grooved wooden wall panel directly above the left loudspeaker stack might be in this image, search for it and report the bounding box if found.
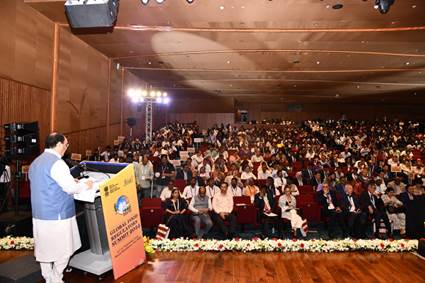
[0,78,50,150]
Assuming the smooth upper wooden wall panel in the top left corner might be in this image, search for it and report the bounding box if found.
[0,0,54,89]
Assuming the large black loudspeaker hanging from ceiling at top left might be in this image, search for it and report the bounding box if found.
[65,0,119,28]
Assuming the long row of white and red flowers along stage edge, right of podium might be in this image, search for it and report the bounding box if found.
[151,239,418,253]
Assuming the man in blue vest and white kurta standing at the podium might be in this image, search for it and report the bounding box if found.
[29,133,93,283]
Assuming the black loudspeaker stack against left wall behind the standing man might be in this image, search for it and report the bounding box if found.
[4,122,40,159]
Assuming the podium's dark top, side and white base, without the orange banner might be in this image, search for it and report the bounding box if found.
[69,161,128,276]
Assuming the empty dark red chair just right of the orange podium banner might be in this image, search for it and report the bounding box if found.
[140,198,164,229]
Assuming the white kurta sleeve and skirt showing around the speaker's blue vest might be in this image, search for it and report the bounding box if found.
[32,149,87,262]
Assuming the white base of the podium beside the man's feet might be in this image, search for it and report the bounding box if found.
[69,250,112,276]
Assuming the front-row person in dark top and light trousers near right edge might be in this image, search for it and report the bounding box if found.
[381,188,406,236]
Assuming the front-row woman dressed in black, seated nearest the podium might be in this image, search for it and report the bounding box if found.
[165,189,192,239]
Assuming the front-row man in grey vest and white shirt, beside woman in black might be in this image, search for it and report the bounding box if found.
[189,187,213,239]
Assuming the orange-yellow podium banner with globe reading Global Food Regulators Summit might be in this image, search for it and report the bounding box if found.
[100,164,146,279]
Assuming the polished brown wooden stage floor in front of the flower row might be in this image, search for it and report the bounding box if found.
[0,251,425,283]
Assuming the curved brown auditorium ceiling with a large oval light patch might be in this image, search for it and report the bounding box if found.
[25,0,425,103]
